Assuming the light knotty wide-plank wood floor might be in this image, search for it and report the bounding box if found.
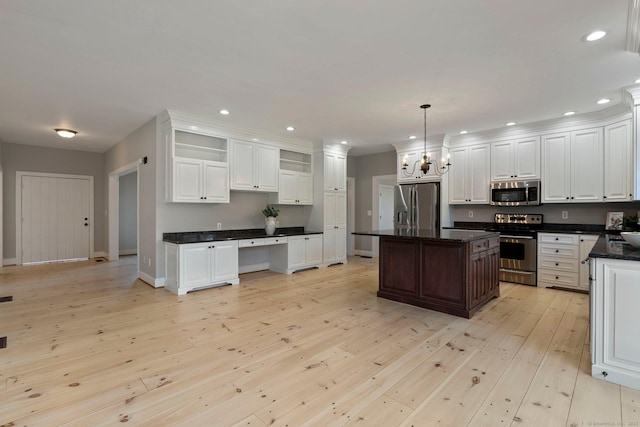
[0,257,640,427]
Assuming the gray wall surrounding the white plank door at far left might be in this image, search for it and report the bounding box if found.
[2,141,107,259]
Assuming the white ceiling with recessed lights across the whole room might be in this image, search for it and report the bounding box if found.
[0,0,640,155]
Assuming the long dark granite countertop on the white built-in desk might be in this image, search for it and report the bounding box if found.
[162,227,322,245]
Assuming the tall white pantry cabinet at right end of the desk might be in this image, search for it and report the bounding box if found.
[308,145,348,266]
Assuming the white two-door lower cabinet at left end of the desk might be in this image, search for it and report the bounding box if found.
[165,240,240,295]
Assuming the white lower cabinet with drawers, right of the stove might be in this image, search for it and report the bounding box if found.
[538,233,598,292]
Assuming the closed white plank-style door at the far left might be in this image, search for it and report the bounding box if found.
[18,174,93,264]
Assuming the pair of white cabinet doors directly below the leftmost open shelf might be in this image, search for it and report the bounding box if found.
[171,157,229,203]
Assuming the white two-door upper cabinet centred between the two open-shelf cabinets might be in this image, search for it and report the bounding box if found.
[230,140,280,192]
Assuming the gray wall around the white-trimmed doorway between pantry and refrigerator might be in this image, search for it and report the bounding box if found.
[347,151,397,251]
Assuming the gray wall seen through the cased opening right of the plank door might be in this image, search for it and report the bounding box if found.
[118,172,138,255]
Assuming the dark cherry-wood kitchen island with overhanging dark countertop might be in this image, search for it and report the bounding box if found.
[353,229,500,319]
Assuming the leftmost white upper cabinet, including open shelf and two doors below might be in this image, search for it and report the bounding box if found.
[169,127,229,203]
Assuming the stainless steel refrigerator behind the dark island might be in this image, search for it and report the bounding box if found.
[393,182,440,230]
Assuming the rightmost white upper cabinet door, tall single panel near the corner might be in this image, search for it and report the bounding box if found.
[604,120,634,202]
